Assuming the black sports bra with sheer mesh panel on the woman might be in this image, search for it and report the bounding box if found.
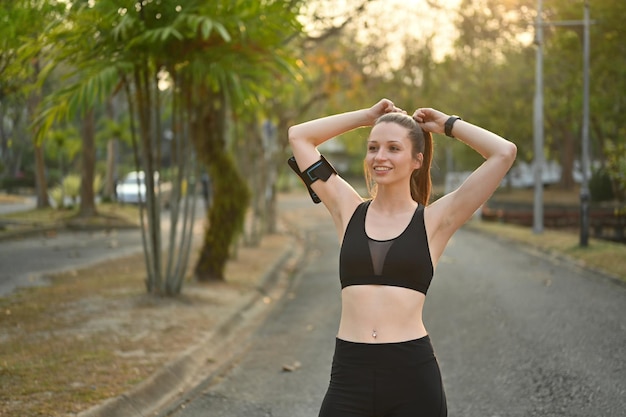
[339,201,434,294]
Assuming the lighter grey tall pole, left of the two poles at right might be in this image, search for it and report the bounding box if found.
[533,0,544,234]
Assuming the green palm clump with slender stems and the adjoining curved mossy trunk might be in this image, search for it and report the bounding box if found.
[35,0,299,295]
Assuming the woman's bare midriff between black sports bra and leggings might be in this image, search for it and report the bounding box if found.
[337,285,427,343]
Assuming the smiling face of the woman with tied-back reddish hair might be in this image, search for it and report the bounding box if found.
[365,122,422,185]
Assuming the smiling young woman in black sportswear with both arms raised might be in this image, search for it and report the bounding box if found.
[289,99,516,417]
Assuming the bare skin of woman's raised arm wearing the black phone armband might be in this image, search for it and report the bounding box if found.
[289,99,404,232]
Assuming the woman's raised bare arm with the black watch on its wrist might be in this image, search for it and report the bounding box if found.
[413,108,517,250]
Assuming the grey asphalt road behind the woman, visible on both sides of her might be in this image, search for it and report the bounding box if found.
[163,198,626,417]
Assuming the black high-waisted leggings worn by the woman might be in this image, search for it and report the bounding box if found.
[319,336,448,417]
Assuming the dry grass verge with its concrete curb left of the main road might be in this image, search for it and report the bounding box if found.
[0,194,313,417]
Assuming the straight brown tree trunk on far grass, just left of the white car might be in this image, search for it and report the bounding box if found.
[78,108,97,217]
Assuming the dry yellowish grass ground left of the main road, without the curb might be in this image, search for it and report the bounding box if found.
[0,199,290,417]
